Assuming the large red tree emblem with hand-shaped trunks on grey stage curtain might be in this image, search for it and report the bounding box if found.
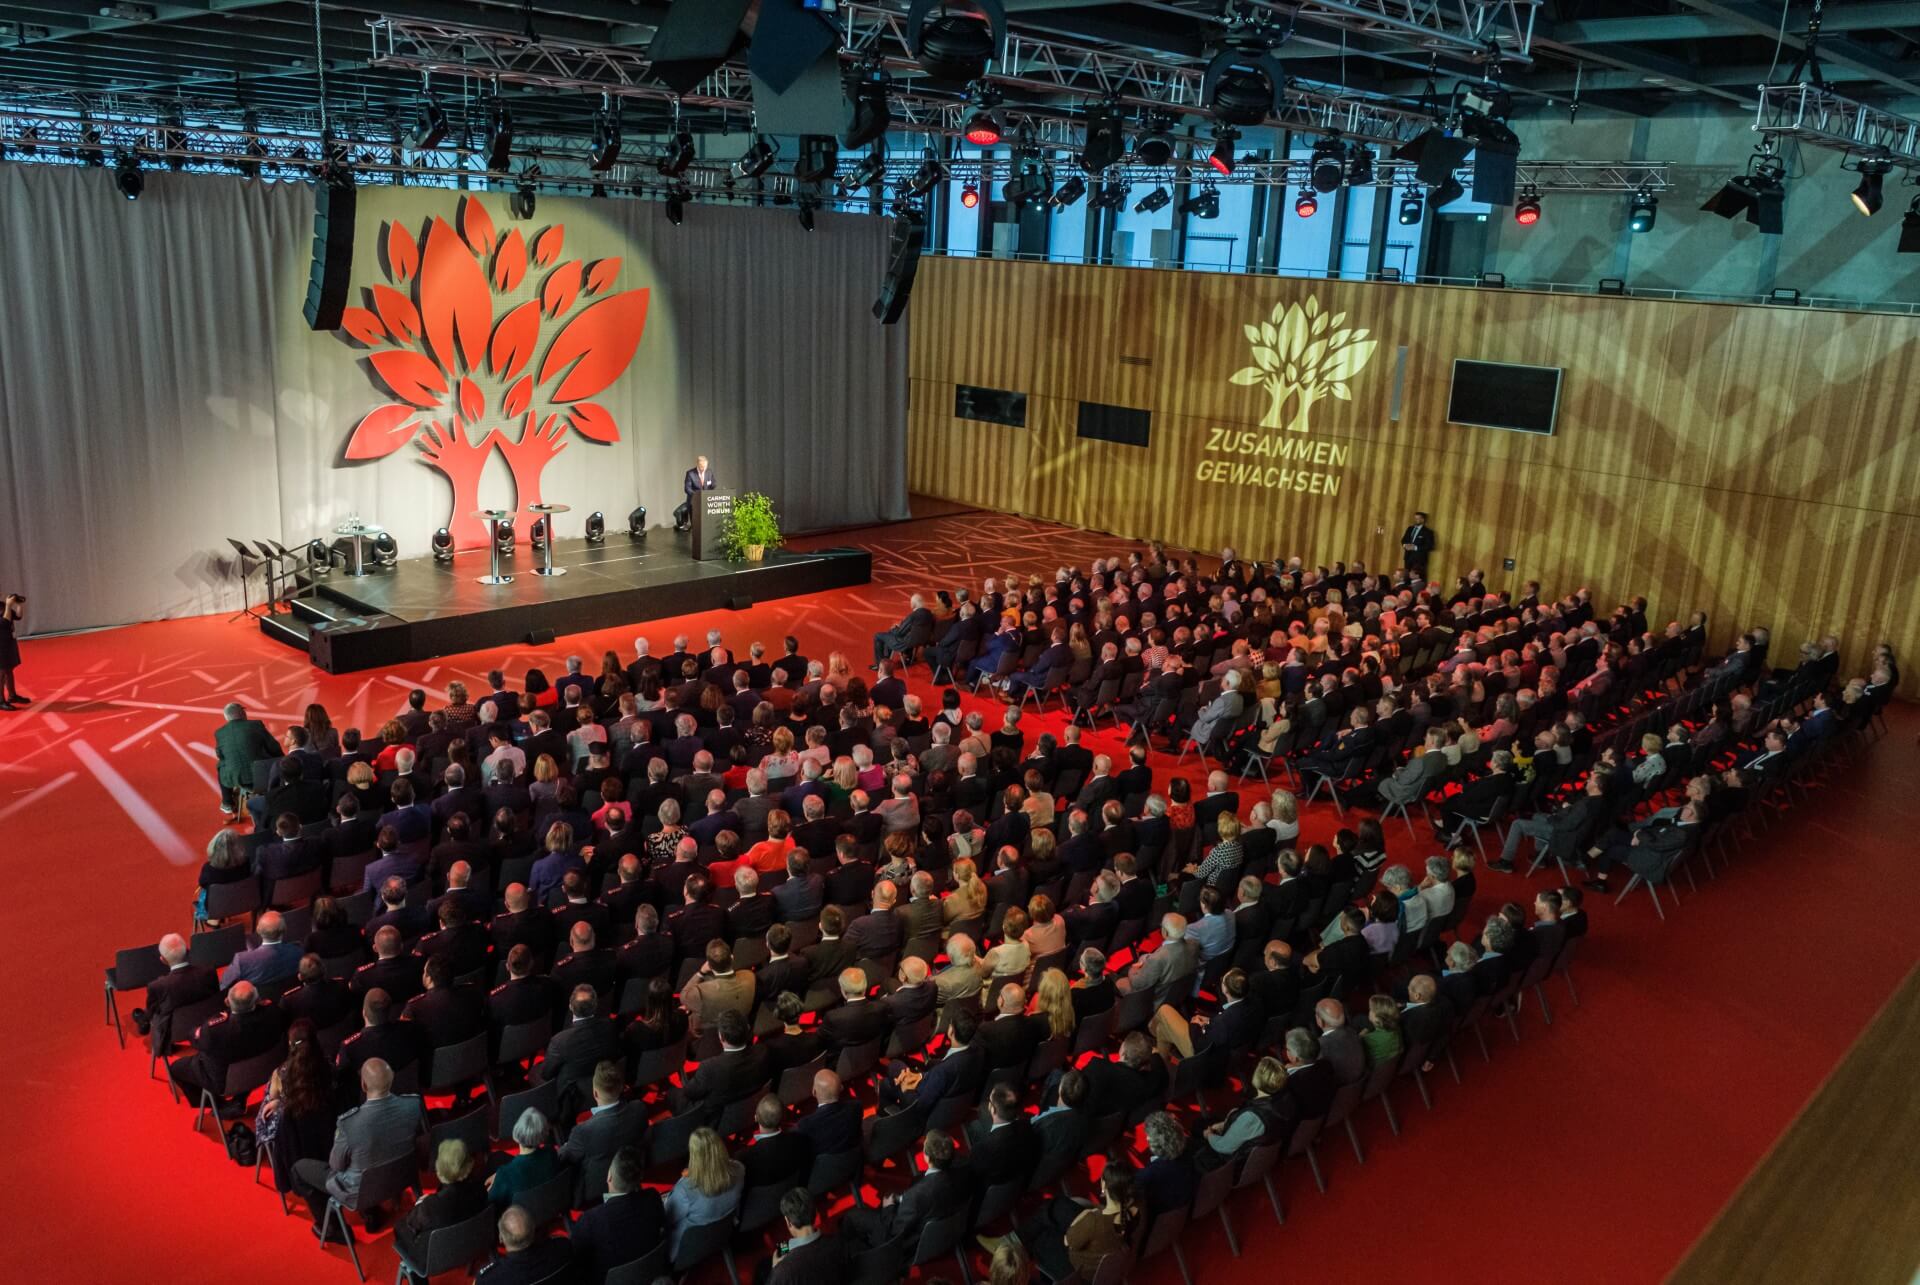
[342,196,647,549]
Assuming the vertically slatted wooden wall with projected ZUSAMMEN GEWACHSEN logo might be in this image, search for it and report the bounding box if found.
[910,259,1920,691]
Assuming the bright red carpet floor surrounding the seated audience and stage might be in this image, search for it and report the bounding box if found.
[0,517,1920,1285]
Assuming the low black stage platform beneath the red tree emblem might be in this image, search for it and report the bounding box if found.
[261,530,874,674]
